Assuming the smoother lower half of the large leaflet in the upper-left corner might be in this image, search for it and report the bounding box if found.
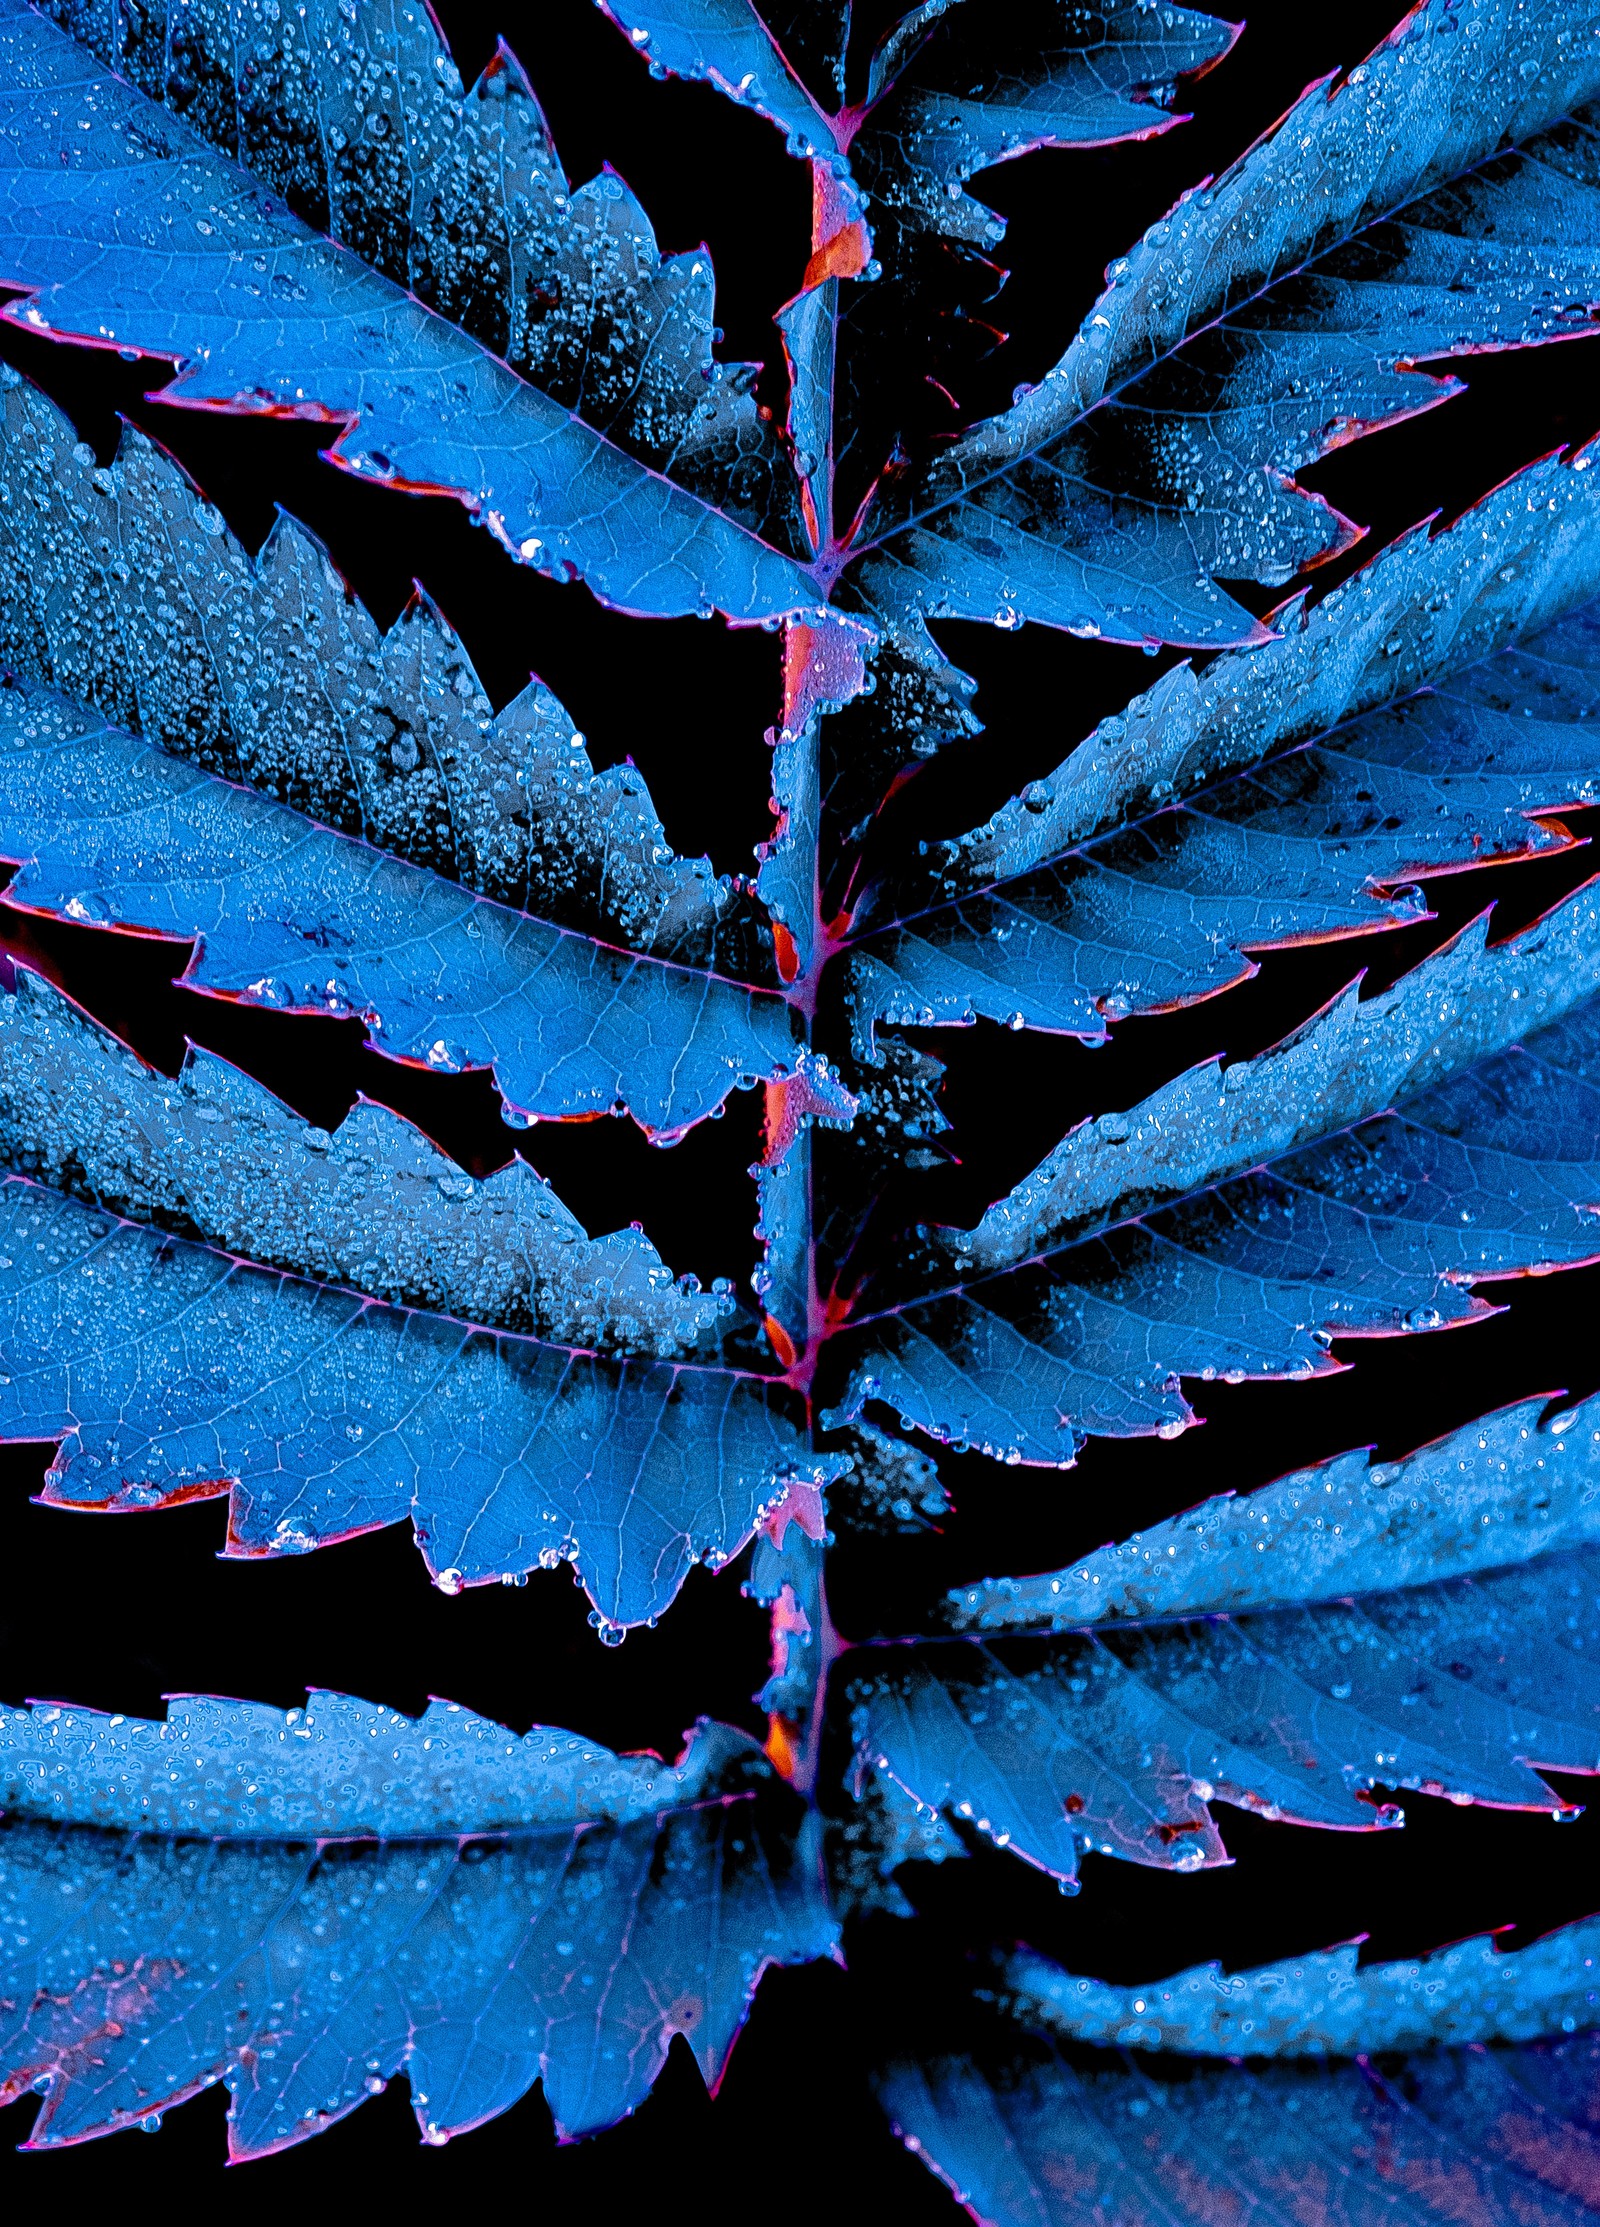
[0,0,820,619]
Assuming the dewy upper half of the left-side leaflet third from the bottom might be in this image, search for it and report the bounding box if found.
[0,370,773,980]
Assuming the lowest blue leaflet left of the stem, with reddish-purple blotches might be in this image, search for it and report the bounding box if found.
[0,1695,833,2158]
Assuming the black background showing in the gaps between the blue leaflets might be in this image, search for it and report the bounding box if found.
[0,0,1600,2227]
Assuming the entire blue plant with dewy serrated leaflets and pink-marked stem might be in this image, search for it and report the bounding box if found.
[0,0,1600,2191]
